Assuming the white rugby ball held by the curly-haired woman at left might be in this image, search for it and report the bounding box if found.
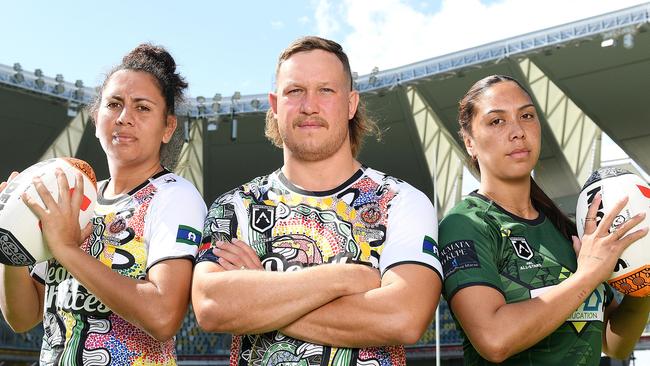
[0,158,97,266]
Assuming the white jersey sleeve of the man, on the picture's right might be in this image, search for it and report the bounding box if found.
[379,186,442,279]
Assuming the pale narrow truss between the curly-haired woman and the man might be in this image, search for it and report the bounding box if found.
[175,118,204,196]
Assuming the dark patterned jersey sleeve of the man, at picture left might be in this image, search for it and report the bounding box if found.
[196,191,239,263]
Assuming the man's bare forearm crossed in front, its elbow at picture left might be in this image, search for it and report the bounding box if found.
[192,263,379,334]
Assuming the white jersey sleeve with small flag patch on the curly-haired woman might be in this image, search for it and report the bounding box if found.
[145,180,206,270]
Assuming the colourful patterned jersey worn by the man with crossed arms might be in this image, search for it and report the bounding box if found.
[197,167,442,366]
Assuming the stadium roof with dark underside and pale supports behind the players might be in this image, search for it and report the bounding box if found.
[0,3,650,211]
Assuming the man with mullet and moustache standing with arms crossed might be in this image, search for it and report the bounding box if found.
[192,37,442,366]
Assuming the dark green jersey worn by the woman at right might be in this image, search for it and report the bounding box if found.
[440,192,613,365]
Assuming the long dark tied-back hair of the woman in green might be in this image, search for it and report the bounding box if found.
[458,75,578,241]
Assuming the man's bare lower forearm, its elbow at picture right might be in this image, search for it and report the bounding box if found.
[280,265,441,348]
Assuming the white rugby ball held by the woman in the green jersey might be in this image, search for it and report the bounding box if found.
[576,168,650,297]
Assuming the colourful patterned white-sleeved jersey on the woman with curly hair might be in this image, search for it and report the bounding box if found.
[32,171,206,366]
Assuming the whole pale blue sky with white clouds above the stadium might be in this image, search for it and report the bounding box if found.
[0,0,639,97]
